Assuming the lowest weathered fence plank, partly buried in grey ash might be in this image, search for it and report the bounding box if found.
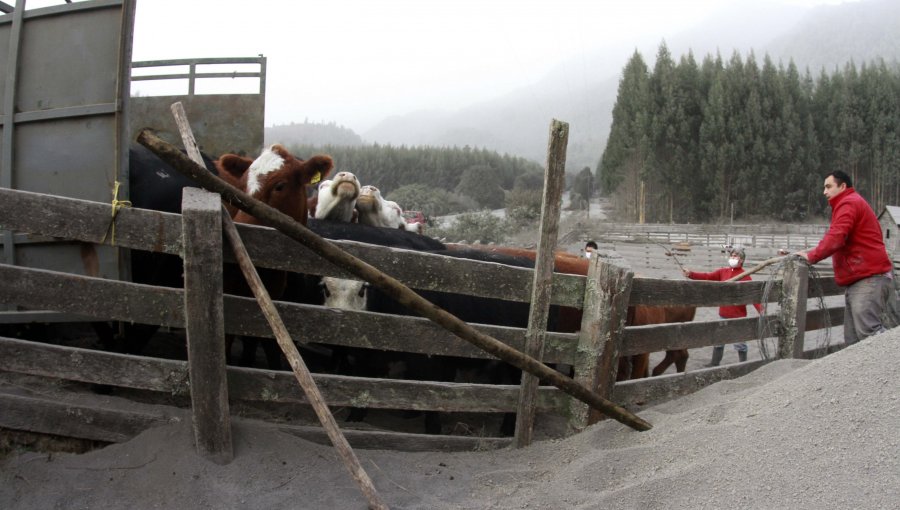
[0,392,511,452]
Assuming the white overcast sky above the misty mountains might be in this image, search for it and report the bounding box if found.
[26,0,847,132]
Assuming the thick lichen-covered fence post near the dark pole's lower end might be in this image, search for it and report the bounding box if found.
[569,252,634,431]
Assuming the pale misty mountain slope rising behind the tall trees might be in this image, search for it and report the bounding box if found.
[363,0,900,172]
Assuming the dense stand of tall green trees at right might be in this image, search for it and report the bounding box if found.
[597,44,900,223]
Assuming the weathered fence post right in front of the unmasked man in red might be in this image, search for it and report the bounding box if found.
[778,257,809,359]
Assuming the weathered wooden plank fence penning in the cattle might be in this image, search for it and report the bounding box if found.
[0,189,843,450]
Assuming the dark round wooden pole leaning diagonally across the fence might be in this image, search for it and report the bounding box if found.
[138,129,653,430]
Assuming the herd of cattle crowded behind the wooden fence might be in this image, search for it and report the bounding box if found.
[103,144,694,435]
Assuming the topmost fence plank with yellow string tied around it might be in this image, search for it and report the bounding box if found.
[0,188,584,306]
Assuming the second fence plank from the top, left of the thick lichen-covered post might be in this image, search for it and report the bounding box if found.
[0,264,576,364]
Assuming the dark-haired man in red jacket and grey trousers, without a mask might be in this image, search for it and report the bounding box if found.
[797,170,893,345]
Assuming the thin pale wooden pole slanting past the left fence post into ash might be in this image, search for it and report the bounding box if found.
[172,103,388,509]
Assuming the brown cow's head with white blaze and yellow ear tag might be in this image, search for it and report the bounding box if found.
[216,144,334,225]
